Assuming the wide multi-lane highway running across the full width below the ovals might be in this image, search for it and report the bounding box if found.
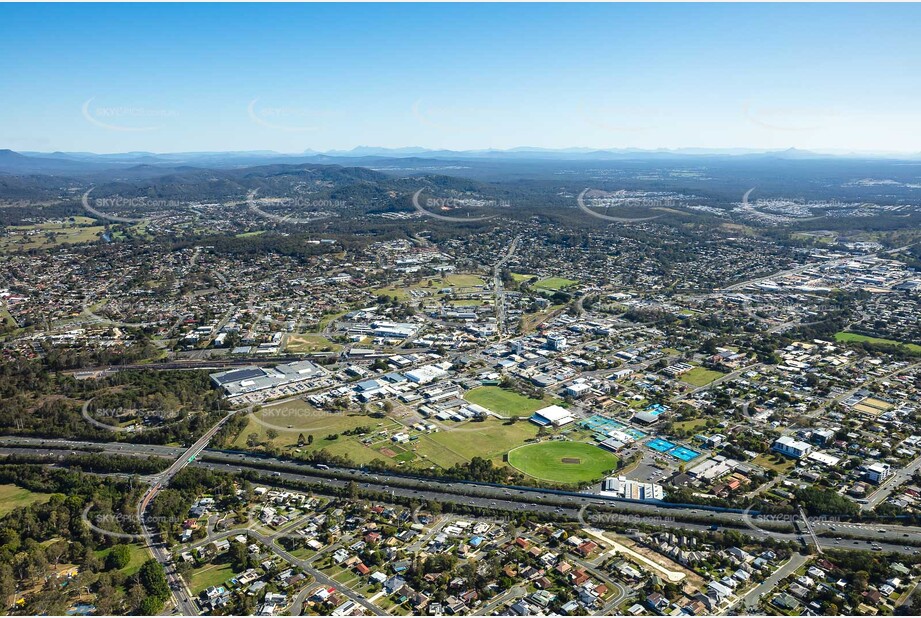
[7,437,921,554]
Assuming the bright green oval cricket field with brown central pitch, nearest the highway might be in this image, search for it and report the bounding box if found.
[508,441,617,484]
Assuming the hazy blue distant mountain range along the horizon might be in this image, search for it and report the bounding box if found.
[0,146,921,176]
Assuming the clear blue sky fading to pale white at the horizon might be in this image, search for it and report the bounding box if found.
[0,4,921,152]
